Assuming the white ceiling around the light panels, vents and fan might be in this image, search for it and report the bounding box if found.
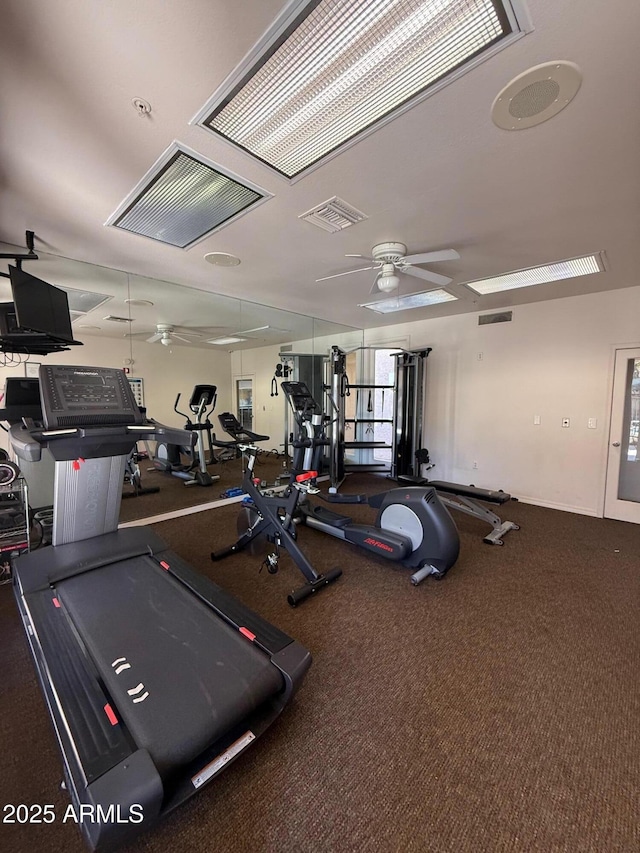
[0,0,640,328]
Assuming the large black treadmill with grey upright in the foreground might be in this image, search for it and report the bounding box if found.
[10,365,311,850]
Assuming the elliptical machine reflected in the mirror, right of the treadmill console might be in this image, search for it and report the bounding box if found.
[151,385,220,486]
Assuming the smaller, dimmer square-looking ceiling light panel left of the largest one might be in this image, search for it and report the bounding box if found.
[105,142,271,249]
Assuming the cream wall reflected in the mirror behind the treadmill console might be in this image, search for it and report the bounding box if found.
[0,335,231,447]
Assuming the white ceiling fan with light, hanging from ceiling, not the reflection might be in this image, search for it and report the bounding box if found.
[316,243,460,293]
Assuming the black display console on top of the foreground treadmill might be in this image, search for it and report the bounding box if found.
[40,364,143,429]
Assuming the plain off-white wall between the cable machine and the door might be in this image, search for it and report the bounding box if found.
[365,287,640,515]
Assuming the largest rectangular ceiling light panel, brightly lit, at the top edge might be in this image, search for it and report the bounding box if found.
[194,0,518,178]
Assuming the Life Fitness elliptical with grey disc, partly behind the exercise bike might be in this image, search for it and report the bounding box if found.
[281,382,460,585]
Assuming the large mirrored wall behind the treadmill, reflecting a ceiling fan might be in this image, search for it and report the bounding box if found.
[0,241,363,520]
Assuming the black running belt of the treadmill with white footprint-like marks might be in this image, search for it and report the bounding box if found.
[56,556,284,776]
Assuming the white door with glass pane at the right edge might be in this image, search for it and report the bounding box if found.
[604,348,640,524]
